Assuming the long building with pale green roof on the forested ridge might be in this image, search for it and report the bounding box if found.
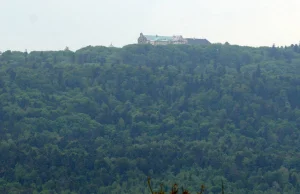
[138,33,210,45]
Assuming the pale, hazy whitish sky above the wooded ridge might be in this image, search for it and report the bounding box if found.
[0,0,300,51]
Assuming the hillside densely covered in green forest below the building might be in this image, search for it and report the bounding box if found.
[0,44,300,194]
